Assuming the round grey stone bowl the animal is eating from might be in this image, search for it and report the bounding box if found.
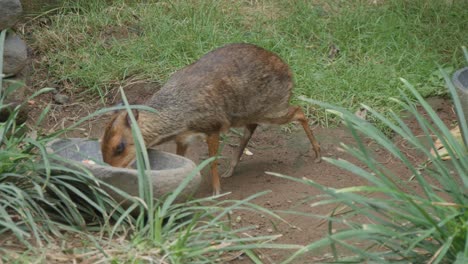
[47,138,201,207]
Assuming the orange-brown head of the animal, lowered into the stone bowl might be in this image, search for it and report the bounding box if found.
[101,110,138,168]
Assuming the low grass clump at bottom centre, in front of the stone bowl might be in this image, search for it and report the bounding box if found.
[124,192,300,263]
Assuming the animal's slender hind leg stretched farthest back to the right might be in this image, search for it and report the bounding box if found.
[267,106,322,162]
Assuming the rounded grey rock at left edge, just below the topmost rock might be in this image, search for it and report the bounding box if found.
[0,32,28,76]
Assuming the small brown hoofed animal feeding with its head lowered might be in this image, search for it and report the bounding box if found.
[101,44,321,194]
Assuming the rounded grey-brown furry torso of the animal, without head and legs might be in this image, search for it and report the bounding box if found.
[147,44,293,130]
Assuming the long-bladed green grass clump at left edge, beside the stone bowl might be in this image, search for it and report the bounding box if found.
[0,28,133,252]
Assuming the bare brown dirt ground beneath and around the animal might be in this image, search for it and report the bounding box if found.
[26,84,455,263]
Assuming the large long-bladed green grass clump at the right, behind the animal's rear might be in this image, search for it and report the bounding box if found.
[272,51,468,263]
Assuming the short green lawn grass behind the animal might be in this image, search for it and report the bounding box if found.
[29,0,468,124]
